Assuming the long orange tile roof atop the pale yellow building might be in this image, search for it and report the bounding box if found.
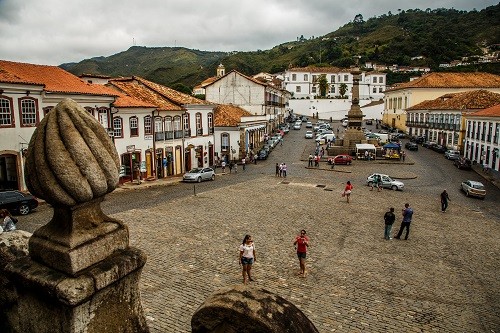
[386,72,500,92]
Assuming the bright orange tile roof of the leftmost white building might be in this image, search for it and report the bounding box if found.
[0,60,116,96]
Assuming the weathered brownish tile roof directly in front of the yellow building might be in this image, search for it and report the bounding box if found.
[406,89,500,111]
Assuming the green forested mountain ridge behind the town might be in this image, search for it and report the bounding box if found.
[61,3,500,88]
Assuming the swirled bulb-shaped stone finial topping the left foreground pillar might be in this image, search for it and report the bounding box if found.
[25,99,120,206]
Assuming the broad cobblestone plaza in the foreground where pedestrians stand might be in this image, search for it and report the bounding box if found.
[113,167,500,332]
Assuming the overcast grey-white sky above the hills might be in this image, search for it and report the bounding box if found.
[0,0,498,65]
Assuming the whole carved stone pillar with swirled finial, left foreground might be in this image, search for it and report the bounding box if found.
[6,99,149,333]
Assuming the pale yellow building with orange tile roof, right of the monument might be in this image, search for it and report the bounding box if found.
[382,73,500,133]
